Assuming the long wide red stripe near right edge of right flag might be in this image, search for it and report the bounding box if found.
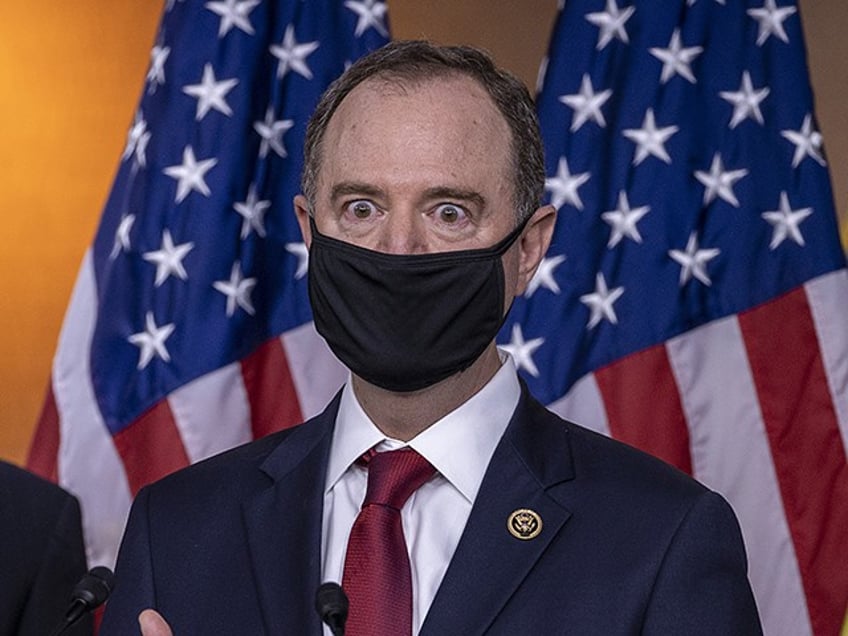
[739,288,848,634]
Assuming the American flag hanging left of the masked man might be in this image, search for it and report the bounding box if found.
[28,0,388,564]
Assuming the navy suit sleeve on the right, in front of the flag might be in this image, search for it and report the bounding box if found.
[642,491,762,636]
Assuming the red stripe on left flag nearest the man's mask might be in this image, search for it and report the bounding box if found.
[241,338,303,439]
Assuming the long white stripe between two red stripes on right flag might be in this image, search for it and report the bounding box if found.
[666,317,812,636]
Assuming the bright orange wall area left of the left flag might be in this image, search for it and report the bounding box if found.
[0,0,159,463]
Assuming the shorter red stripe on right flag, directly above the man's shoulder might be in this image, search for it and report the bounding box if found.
[595,345,692,475]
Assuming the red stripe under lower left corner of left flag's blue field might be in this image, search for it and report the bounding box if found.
[112,400,189,497]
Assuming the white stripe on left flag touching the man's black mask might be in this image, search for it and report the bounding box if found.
[280,322,348,420]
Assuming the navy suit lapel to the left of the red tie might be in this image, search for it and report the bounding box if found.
[243,396,338,636]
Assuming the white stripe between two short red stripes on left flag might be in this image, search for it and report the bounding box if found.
[168,362,253,463]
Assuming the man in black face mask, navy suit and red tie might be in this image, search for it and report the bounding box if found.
[103,42,760,636]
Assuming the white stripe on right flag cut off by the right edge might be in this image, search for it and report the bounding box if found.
[804,269,848,455]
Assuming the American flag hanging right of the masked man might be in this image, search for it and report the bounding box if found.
[501,0,848,636]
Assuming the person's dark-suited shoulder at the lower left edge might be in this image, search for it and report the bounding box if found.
[0,462,92,636]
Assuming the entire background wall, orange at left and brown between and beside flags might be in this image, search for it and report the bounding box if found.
[0,0,848,463]
